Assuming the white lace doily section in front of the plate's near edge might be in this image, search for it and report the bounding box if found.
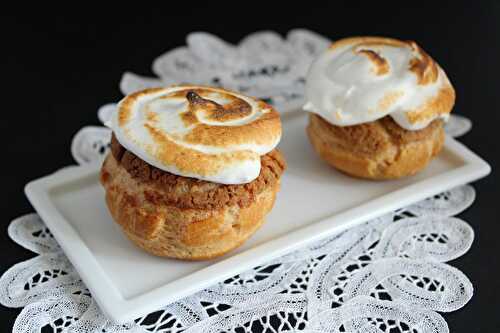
[0,185,474,332]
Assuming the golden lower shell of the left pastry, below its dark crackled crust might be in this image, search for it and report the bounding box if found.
[101,154,280,260]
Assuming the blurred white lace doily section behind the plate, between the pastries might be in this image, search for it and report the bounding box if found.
[120,29,330,110]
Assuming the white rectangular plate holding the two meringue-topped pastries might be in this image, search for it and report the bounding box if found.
[26,113,490,322]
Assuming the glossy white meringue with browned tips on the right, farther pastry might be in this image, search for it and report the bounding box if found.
[304,37,455,130]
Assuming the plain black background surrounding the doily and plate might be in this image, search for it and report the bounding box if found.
[0,1,500,332]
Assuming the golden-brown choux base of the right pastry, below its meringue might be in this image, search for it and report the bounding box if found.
[307,114,444,180]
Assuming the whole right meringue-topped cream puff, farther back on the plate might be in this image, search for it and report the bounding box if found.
[304,37,455,179]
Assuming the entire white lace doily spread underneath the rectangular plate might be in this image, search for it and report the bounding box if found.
[0,30,475,333]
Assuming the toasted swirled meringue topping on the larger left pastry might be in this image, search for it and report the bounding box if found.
[110,86,281,184]
